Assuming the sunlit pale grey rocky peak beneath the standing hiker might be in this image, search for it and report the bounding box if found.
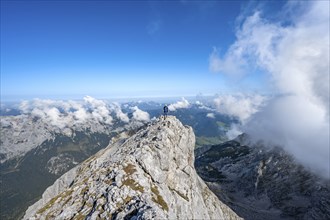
[24,116,240,219]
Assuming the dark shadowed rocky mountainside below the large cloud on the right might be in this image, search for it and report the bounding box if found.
[195,136,330,220]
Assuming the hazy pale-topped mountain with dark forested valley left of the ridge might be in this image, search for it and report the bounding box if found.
[0,114,120,219]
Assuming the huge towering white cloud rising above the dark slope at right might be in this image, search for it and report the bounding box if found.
[210,1,330,178]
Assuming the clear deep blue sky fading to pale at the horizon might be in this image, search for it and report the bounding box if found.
[1,1,285,100]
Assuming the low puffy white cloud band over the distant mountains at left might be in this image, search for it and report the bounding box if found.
[19,96,129,129]
